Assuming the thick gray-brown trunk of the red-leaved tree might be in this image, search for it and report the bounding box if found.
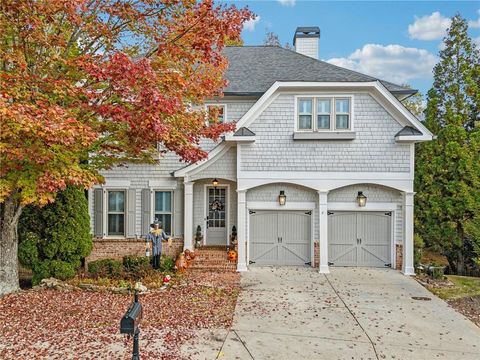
[0,194,22,296]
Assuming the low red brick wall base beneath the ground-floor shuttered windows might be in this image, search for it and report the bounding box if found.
[85,238,183,264]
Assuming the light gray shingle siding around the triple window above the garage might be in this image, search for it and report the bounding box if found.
[241,93,410,172]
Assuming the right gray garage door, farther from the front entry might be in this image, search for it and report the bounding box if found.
[328,212,392,267]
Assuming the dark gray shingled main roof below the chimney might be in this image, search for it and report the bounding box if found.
[223,46,417,96]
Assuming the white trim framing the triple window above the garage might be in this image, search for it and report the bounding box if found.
[294,93,355,133]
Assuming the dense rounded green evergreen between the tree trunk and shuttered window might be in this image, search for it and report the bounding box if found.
[18,186,92,285]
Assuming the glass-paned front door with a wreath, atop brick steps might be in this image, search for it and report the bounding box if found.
[205,186,228,245]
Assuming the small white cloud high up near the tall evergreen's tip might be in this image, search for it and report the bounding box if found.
[408,11,451,40]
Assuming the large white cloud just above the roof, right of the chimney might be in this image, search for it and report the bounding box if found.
[327,44,437,84]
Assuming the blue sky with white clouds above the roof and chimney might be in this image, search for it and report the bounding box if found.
[220,0,480,93]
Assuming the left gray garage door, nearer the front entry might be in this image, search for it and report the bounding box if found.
[249,210,312,265]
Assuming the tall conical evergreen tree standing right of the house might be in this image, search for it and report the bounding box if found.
[415,14,480,274]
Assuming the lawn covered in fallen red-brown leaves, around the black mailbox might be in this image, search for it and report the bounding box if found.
[0,272,239,360]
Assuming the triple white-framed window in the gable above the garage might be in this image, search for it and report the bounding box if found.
[296,96,352,131]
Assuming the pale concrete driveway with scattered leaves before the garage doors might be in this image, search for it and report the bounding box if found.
[218,267,480,360]
